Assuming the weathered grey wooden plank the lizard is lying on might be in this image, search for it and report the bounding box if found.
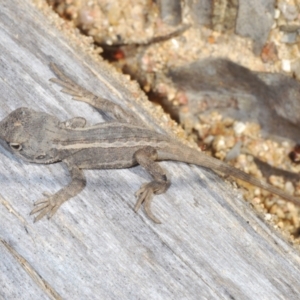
[0,0,300,299]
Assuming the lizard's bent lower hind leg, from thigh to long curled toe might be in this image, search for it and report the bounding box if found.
[134,146,170,224]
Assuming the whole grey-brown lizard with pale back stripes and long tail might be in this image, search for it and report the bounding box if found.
[0,63,300,223]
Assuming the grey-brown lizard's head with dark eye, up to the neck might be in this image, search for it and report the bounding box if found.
[0,107,60,164]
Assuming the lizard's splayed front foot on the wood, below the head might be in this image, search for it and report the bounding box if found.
[30,192,64,223]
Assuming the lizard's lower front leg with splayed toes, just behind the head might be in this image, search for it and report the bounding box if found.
[30,161,86,222]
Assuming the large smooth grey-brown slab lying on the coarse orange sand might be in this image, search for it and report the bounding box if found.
[169,58,300,143]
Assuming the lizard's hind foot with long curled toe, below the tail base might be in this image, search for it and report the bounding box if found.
[134,181,168,224]
